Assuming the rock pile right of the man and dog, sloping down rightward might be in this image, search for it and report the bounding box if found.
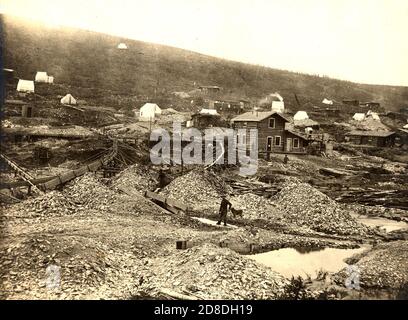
[271,178,369,235]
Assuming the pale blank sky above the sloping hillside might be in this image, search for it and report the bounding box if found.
[0,0,408,86]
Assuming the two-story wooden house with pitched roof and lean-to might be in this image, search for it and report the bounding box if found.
[231,111,309,156]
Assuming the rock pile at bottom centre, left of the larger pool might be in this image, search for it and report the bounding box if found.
[141,244,287,299]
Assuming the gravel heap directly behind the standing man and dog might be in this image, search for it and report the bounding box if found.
[161,170,232,213]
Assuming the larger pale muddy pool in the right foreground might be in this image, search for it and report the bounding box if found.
[248,246,370,278]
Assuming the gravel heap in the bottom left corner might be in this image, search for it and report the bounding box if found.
[0,234,138,299]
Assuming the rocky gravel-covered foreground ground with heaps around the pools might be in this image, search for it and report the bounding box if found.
[0,171,408,299]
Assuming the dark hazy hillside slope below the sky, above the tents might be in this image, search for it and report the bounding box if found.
[3,16,408,110]
